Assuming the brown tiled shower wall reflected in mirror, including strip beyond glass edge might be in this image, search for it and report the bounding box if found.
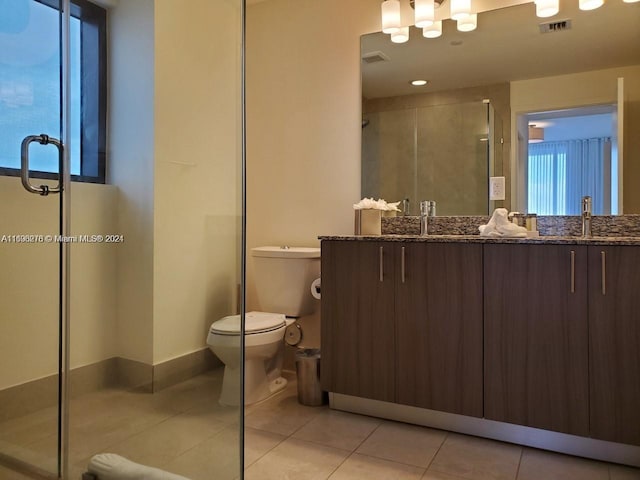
[362,84,510,215]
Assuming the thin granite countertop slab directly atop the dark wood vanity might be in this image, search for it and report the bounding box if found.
[318,235,640,245]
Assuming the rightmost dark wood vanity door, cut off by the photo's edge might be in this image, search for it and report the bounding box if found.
[589,246,640,445]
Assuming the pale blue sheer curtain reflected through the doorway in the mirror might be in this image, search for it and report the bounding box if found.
[527,137,611,215]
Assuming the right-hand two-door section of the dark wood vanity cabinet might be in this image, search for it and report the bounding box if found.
[484,245,640,445]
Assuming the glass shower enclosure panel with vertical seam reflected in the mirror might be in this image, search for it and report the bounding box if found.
[362,101,492,215]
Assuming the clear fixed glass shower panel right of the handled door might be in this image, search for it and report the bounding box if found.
[69,0,243,480]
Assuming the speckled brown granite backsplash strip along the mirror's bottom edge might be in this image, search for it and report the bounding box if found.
[382,215,640,237]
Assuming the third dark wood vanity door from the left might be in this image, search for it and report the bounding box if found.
[484,244,589,436]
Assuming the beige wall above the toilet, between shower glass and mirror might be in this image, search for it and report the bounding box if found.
[247,0,380,322]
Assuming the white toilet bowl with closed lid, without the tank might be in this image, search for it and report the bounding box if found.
[207,312,293,406]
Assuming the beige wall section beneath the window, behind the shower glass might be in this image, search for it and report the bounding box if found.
[0,177,117,390]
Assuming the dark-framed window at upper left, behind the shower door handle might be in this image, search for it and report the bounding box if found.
[0,0,107,183]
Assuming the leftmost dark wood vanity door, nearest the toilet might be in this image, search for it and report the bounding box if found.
[320,240,396,402]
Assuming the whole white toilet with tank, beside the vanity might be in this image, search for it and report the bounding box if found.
[207,246,320,406]
